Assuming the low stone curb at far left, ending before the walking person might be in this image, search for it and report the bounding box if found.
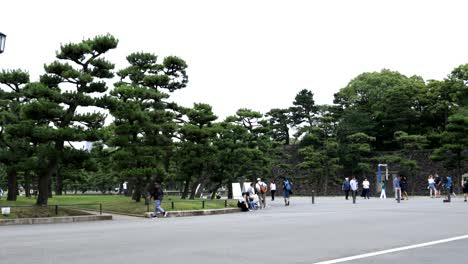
[0,215,112,226]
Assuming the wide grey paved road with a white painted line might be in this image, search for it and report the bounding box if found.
[0,198,468,264]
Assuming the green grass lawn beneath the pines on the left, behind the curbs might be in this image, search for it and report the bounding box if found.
[0,195,237,219]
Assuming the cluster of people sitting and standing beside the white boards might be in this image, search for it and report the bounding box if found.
[237,178,292,212]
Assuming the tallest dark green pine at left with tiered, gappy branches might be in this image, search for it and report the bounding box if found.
[23,35,117,205]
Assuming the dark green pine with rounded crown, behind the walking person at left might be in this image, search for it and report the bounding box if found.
[108,53,187,202]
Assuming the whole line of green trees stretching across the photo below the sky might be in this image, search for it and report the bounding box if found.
[0,35,468,205]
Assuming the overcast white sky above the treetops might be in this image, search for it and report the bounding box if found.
[0,0,468,117]
